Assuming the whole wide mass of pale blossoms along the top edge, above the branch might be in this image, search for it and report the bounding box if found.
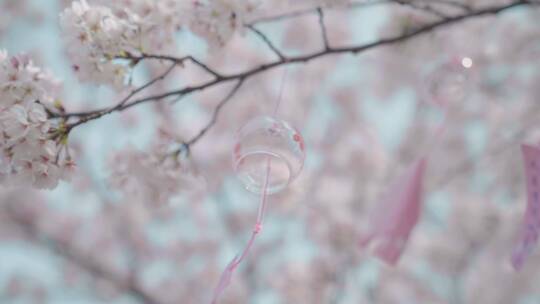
[60,0,258,88]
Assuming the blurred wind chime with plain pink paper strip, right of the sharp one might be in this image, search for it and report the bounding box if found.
[359,57,472,265]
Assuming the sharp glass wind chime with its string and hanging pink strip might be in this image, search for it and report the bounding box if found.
[211,70,305,304]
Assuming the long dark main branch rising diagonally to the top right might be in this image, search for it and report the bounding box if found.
[62,0,538,145]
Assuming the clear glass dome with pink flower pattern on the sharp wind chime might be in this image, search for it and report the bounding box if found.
[233,116,305,194]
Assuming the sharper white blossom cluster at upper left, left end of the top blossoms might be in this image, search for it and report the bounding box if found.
[60,0,140,87]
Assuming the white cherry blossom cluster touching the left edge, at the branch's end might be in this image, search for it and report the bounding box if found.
[0,51,75,189]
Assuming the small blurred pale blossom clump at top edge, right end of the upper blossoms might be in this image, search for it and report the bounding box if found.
[190,0,259,49]
